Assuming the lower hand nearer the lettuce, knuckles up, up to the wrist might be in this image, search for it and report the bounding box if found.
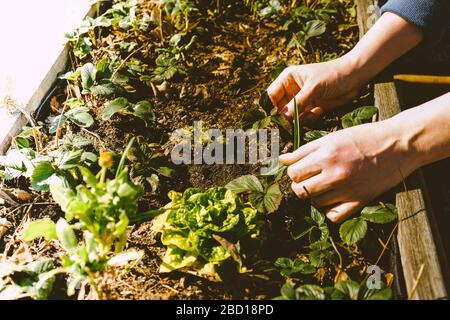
[280,120,420,222]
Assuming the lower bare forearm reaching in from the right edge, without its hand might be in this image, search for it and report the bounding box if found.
[387,93,450,168]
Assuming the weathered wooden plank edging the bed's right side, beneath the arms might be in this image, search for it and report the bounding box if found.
[355,0,448,300]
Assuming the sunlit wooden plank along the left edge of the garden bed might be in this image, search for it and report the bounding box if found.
[0,4,98,155]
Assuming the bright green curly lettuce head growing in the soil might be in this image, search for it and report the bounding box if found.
[153,187,261,280]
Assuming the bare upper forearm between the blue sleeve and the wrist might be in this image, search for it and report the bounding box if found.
[342,12,423,86]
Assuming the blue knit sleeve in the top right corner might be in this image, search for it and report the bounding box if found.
[381,0,450,45]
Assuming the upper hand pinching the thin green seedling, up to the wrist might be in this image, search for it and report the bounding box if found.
[267,57,362,119]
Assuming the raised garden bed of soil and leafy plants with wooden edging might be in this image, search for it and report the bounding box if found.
[0,0,446,299]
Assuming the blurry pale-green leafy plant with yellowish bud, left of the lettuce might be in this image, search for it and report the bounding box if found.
[22,142,142,295]
